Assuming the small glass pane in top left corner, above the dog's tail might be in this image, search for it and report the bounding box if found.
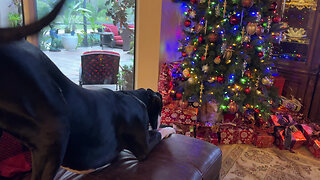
[0,0,23,27]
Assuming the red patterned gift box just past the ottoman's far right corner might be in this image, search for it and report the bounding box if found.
[219,123,239,144]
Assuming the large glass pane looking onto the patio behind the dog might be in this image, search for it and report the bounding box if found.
[36,0,135,90]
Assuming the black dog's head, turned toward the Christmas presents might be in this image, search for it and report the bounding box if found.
[147,89,163,129]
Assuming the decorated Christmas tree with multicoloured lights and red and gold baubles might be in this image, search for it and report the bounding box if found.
[175,0,287,119]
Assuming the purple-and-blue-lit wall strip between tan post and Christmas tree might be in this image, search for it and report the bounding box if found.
[160,0,183,63]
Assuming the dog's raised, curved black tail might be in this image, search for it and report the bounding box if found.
[0,0,65,43]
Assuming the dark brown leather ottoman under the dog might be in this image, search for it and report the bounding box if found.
[23,134,222,180]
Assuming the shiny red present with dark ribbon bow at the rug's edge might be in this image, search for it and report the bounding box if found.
[270,115,306,150]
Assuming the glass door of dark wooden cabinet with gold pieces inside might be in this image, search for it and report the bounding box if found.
[274,0,317,62]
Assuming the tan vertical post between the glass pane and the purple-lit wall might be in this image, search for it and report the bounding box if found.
[135,0,162,90]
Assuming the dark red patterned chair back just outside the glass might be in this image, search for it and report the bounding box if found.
[79,51,120,85]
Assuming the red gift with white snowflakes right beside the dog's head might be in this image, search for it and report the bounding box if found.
[161,103,198,125]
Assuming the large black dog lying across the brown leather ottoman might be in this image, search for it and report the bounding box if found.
[0,2,162,180]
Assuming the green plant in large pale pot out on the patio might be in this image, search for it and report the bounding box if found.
[61,1,90,50]
